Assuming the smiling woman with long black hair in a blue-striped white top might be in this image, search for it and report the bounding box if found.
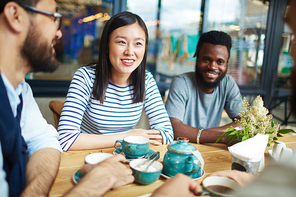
[58,12,173,150]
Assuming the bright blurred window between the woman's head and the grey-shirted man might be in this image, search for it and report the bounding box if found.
[127,0,201,81]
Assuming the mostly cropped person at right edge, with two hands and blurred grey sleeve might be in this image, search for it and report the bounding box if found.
[151,0,296,197]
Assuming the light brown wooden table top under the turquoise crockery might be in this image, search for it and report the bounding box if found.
[49,134,296,197]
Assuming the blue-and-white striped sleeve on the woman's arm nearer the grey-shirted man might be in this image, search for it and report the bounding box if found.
[144,72,174,144]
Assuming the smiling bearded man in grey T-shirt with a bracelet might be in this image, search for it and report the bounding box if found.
[166,31,242,144]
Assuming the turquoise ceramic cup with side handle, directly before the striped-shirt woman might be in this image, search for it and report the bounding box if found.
[114,136,150,158]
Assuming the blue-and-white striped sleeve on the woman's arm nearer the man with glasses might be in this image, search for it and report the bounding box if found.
[58,67,94,151]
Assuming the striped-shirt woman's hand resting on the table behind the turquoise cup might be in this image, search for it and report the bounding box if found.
[128,129,162,145]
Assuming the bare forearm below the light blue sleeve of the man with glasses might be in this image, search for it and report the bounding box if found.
[21,148,61,197]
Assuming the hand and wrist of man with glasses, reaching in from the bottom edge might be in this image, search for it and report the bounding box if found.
[65,155,134,197]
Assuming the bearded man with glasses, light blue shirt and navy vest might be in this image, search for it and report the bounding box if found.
[0,0,133,197]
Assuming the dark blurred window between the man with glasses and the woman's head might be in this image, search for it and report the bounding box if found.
[27,0,113,80]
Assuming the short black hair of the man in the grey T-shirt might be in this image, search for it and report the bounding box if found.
[194,31,232,60]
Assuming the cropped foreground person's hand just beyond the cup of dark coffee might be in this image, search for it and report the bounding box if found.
[209,170,256,187]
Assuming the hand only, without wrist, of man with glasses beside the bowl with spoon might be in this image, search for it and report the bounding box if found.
[80,154,134,189]
